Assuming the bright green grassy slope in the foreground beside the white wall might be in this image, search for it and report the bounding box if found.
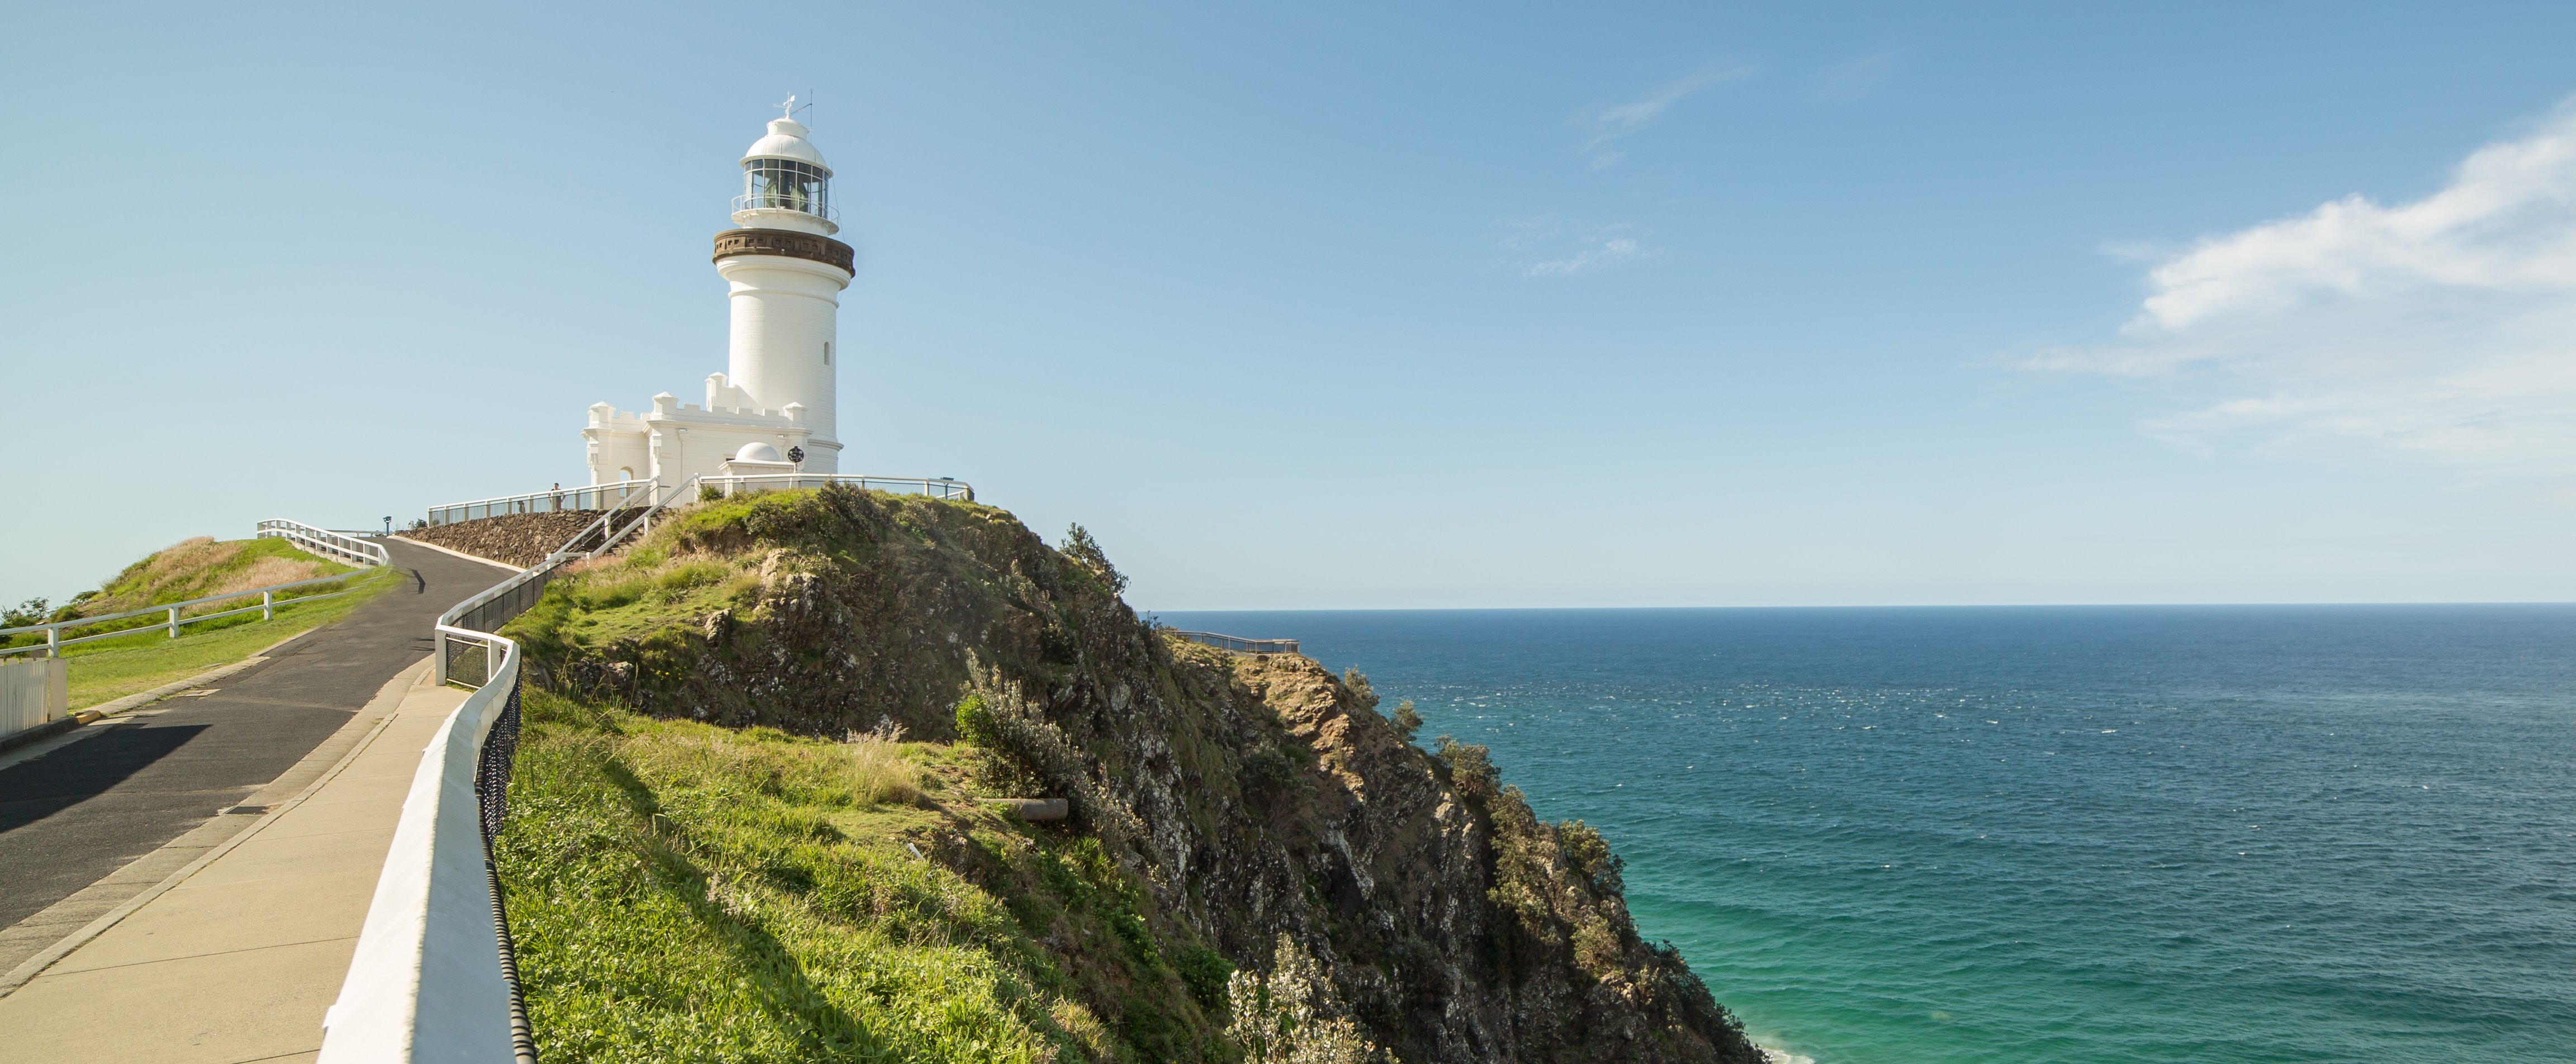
[495,688,1226,1064]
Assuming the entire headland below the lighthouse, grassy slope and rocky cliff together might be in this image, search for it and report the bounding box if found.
[497,490,1759,1064]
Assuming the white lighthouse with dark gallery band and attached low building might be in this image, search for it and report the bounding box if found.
[582,101,853,484]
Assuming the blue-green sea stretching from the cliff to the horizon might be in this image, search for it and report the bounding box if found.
[1162,605,2576,1064]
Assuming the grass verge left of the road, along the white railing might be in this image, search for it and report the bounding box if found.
[62,569,402,709]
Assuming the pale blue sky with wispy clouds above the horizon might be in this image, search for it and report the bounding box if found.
[0,3,2576,611]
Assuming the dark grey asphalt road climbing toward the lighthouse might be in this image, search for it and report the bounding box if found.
[0,539,508,928]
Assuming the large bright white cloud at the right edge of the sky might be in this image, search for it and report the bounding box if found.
[2030,101,2576,479]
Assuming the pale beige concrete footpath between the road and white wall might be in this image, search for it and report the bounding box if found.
[0,662,466,1064]
